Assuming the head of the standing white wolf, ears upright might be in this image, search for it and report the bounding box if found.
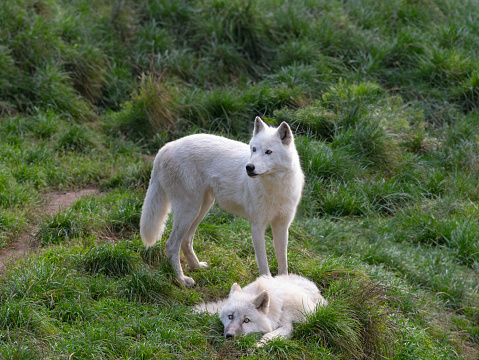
[246,116,299,177]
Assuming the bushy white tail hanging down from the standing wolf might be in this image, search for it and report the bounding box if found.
[140,174,170,248]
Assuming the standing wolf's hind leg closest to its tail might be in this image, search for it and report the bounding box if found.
[166,201,201,286]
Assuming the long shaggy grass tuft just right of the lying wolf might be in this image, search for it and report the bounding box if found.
[294,280,398,359]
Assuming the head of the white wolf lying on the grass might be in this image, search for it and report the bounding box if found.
[220,283,272,338]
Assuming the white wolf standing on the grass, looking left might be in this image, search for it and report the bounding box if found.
[140,117,304,286]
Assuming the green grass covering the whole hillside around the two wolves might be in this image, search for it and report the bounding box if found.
[0,0,479,359]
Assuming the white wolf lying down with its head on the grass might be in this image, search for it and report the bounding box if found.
[196,275,328,343]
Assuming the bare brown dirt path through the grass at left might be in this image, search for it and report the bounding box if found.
[0,188,99,273]
